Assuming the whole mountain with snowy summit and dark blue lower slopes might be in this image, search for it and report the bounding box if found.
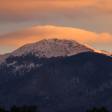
[0,39,112,112]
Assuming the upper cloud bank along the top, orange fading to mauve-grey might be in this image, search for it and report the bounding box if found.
[0,0,112,21]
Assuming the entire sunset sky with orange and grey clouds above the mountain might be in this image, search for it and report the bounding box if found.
[0,0,112,54]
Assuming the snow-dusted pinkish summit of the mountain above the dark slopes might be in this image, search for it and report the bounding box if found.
[11,39,94,58]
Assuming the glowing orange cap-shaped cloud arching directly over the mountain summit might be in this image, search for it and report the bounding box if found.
[0,25,112,50]
